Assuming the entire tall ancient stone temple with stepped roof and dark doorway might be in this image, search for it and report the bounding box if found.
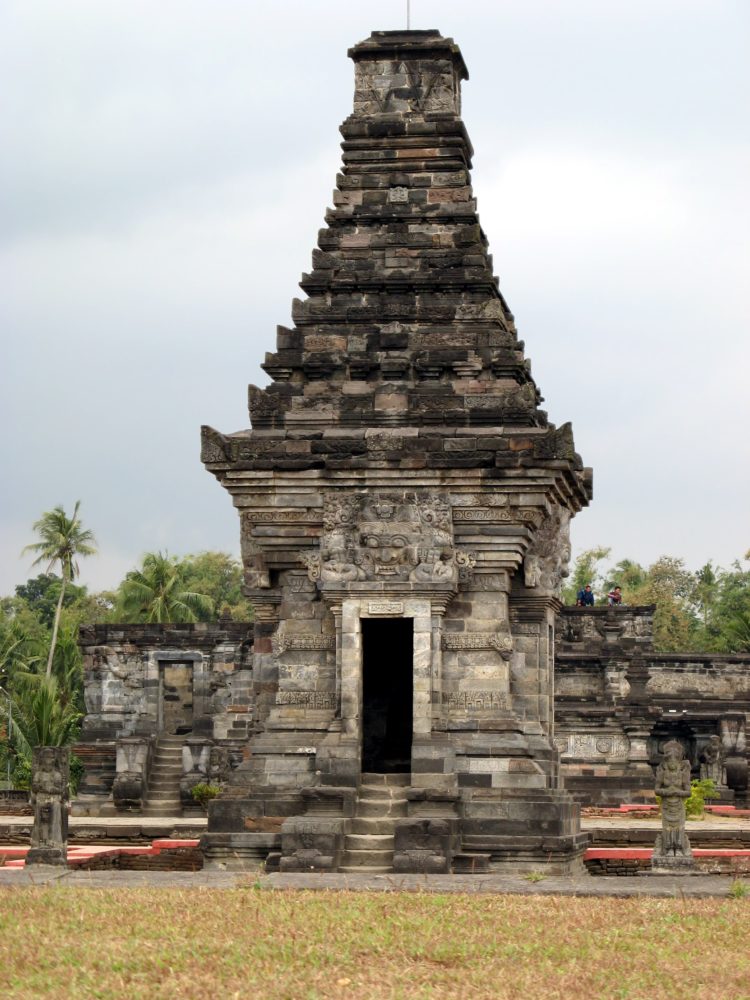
[202,31,591,871]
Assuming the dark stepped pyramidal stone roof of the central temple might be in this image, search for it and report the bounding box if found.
[202,30,591,509]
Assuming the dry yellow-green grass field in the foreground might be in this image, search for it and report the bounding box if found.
[0,886,750,1000]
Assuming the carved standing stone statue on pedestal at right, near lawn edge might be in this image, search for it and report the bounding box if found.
[651,740,695,870]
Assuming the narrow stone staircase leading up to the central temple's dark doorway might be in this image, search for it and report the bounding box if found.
[339,774,410,875]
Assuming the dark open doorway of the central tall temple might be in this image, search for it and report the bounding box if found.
[362,618,414,774]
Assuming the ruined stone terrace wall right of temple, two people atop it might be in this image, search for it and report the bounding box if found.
[555,607,750,804]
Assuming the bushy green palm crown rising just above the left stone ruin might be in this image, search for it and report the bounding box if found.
[115,552,213,624]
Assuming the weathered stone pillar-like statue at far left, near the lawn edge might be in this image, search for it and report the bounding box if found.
[26,747,70,865]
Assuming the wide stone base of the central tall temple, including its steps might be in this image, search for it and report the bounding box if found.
[201,775,587,874]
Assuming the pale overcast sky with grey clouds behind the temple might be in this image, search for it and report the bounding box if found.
[0,0,750,593]
